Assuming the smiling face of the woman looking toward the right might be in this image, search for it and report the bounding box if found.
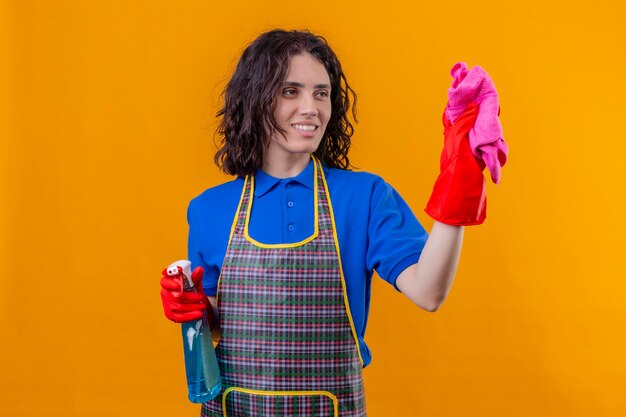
[266,53,331,164]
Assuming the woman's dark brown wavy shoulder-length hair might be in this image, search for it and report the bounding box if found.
[215,29,357,176]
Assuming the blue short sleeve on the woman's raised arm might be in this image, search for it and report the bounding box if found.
[367,179,428,290]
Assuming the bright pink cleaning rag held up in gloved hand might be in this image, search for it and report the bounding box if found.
[444,62,509,184]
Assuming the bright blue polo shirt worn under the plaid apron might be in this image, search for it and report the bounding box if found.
[187,161,428,366]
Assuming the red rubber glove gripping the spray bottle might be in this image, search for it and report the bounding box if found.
[161,266,212,323]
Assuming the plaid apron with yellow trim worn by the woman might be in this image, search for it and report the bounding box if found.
[201,158,366,417]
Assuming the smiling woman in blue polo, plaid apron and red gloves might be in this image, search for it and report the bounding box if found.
[161,30,484,417]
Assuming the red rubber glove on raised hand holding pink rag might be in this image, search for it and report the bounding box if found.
[425,102,487,226]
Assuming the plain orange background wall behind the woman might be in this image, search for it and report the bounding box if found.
[0,0,626,417]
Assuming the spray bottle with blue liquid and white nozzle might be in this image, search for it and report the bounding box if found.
[167,260,222,403]
